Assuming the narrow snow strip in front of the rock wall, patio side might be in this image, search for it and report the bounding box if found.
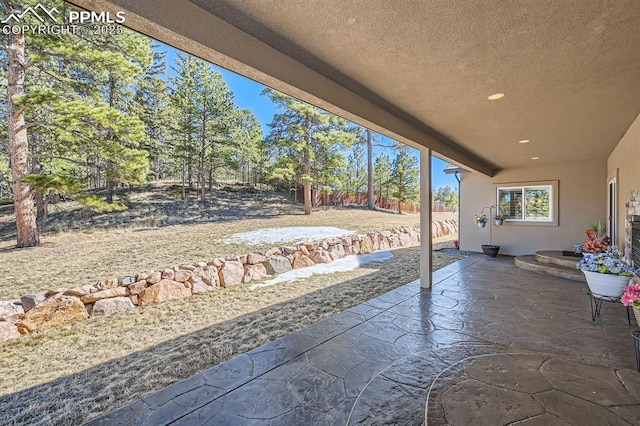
[249,250,393,290]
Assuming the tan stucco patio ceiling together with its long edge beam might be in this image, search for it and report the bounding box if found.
[63,0,640,175]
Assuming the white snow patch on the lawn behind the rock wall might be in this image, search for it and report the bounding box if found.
[221,226,355,245]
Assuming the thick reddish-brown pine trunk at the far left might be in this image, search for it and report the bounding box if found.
[3,28,40,247]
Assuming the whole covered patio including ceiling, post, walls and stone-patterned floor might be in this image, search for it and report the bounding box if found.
[56,0,640,425]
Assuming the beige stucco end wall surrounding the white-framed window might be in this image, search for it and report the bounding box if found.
[460,159,604,256]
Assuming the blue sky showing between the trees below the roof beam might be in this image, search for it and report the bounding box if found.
[158,43,458,189]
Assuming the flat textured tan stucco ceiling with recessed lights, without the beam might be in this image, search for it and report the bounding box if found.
[192,0,640,168]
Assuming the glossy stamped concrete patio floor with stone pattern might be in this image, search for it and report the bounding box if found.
[92,256,640,426]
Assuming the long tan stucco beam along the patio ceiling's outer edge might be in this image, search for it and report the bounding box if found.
[68,0,497,176]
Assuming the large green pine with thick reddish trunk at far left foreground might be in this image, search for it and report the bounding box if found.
[2,0,152,247]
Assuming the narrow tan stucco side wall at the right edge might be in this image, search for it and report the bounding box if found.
[607,111,640,248]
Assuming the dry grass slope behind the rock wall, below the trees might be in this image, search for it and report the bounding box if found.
[0,184,457,300]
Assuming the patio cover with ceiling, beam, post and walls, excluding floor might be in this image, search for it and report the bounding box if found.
[69,0,640,288]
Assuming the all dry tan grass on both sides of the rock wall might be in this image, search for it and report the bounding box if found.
[0,185,460,425]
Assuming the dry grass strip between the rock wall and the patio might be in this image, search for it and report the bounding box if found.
[0,243,460,425]
